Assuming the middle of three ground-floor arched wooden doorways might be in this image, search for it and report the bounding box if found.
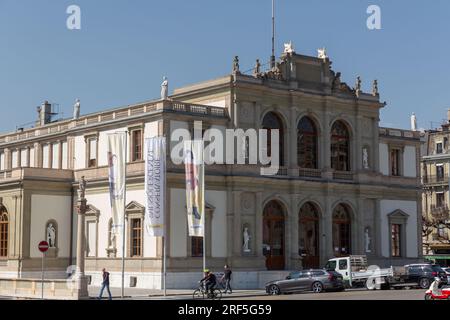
[298,202,320,269]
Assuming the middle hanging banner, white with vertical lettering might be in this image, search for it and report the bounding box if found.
[145,137,166,237]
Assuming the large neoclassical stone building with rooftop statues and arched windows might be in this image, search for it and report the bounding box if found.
[0,48,422,288]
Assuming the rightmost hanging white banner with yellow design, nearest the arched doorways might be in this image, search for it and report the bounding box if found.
[184,140,205,237]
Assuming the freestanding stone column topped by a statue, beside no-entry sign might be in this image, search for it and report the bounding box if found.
[76,181,89,299]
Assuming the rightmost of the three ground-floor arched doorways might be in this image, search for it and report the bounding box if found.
[333,204,352,257]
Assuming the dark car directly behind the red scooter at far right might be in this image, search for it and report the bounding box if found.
[405,264,448,289]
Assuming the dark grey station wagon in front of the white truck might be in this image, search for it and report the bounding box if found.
[266,269,344,295]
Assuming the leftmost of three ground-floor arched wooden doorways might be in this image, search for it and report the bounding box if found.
[263,201,285,270]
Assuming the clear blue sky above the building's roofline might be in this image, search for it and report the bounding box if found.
[0,0,450,132]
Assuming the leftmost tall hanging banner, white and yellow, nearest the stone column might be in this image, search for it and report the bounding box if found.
[108,133,127,234]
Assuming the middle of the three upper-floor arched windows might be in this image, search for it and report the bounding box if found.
[297,117,317,169]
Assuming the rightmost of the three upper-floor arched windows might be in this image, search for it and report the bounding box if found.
[331,121,350,171]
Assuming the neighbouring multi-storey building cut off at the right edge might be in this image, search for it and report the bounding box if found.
[422,111,450,266]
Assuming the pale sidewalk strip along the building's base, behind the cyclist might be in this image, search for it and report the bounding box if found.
[89,286,266,300]
